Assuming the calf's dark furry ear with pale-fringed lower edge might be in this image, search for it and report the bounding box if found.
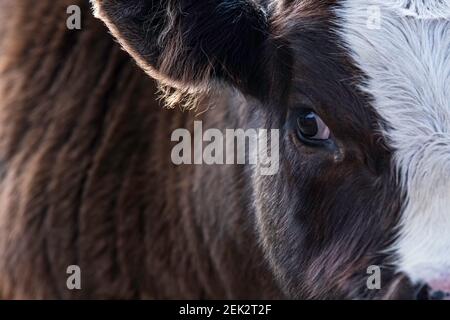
[93,0,269,95]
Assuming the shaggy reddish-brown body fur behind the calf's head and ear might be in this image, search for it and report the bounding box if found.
[0,0,282,298]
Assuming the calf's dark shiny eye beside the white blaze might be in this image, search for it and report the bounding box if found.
[297,110,330,142]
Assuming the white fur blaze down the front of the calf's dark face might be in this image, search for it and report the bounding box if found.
[337,0,450,282]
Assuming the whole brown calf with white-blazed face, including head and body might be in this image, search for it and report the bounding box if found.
[0,0,450,299]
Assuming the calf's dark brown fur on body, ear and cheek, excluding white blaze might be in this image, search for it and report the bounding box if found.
[0,0,414,298]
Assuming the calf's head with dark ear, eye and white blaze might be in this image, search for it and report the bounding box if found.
[94,0,450,298]
